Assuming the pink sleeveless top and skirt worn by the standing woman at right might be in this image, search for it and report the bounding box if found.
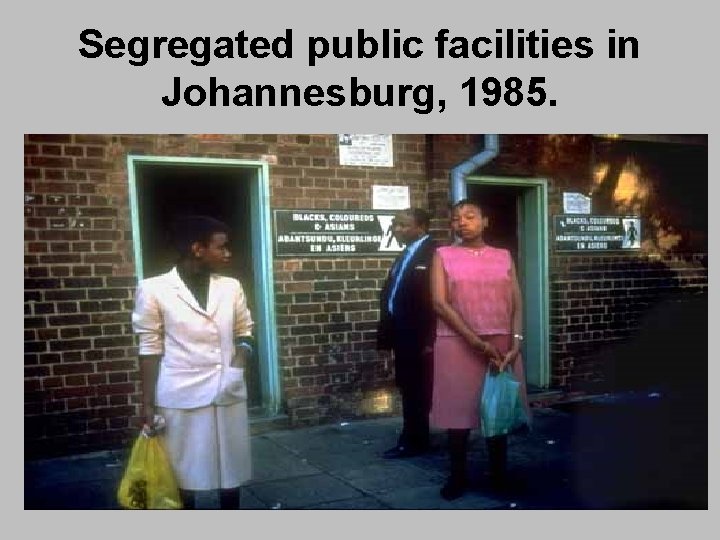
[430,246,527,429]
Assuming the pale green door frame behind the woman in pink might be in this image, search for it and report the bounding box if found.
[467,176,550,389]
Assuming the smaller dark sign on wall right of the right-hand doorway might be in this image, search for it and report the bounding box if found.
[554,214,641,251]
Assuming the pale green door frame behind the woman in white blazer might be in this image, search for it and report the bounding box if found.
[127,155,281,416]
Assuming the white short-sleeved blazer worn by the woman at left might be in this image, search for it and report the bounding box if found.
[132,268,253,409]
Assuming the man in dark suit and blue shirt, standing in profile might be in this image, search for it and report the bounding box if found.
[377,208,436,459]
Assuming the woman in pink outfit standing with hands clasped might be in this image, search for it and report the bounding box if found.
[430,200,529,500]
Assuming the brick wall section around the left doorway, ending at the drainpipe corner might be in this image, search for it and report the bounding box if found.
[24,135,427,456]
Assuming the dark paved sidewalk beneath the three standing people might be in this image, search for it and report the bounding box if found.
[25,394,707,510]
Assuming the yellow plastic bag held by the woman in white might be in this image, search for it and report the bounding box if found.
[117,434,182,510]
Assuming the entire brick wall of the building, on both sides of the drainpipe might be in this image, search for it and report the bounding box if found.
[24,134,707,457]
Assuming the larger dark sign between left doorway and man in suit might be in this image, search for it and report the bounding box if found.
[273,209,403,257]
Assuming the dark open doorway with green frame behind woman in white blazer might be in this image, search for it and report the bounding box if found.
[128,156,280,417]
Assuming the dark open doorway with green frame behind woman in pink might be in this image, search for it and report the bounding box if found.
[467,176,550,391]
